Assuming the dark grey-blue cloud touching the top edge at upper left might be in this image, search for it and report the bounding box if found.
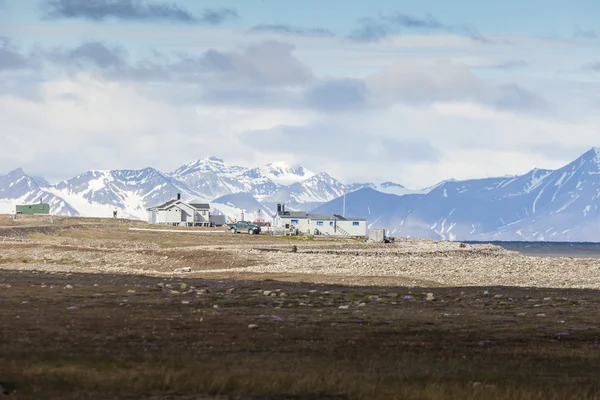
[43,0,238,25]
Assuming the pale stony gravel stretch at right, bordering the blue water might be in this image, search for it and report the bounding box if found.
[199,240,600,289]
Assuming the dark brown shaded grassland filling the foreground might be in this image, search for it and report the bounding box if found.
[0,272,600,399]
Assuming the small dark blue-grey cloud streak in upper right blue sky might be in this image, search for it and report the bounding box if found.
[349,12,490,43]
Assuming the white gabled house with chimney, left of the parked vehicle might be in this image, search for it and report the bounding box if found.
[147,193,213,226]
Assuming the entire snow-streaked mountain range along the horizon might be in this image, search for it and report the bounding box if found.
[0,148,600,241]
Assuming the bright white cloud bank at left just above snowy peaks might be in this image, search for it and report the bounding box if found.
[0,75,310,180]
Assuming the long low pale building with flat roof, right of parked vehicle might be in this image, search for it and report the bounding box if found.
[273,204,367,237]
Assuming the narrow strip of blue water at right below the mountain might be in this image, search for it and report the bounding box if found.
[465,242,600,258]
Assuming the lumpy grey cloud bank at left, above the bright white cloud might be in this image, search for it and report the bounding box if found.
[32,41,315,90]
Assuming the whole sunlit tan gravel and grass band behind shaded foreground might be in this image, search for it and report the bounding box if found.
[0,226,600,289]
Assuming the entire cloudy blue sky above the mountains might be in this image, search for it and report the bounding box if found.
[0,0,600,189]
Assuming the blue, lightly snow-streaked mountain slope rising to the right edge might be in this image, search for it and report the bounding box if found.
[315,148,600,241]
